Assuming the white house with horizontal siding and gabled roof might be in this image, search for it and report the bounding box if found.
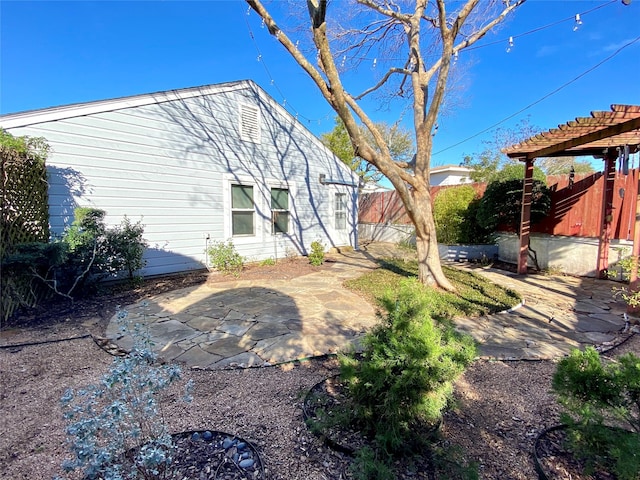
[0,81,358,275]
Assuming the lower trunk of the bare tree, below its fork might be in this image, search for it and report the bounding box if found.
[411,189,455,292]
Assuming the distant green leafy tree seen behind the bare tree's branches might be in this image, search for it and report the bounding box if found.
[320,117,414,187]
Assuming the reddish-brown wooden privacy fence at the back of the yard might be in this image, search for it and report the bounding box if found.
[358,168,638,240]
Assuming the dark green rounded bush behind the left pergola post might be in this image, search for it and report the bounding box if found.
[477,180,551,232]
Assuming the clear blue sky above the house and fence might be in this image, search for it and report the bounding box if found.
[0,0,640,166]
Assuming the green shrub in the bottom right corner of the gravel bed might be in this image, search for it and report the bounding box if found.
[552,347,640,480]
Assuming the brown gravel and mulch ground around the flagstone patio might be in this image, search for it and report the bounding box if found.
[0,259,640,480]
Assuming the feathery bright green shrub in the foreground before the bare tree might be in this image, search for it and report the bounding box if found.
[340,280,475,452]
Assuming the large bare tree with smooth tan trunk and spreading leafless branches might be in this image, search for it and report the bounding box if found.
[246,0,525,290]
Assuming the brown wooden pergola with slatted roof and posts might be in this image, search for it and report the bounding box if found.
[503,105,640,281]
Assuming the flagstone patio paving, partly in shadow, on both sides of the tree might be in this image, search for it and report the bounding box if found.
[107,244,637,368]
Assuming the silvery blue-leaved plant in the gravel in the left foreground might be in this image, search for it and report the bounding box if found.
[61,311,191,480]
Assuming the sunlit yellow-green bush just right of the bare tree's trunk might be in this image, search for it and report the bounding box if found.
[433,185,489,245]
